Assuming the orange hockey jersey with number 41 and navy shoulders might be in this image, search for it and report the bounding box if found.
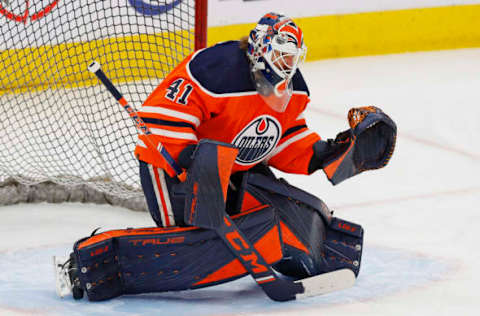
[135,41,320,174]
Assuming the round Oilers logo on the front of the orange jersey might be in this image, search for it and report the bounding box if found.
[232,115,282,165]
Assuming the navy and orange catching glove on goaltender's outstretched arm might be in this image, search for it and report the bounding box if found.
[309,106,397,185]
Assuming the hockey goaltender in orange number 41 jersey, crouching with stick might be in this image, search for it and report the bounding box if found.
[55,13,396,301]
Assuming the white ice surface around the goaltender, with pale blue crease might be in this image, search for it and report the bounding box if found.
[0,49,480,316]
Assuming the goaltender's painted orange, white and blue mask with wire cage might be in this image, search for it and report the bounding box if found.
[247,13,307,112]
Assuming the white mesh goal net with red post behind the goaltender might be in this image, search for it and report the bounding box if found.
[0,0,207,207]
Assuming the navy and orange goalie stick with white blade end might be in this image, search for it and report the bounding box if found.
[88,61,355,301]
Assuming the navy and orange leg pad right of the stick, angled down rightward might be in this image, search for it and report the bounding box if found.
[240,173,363,278]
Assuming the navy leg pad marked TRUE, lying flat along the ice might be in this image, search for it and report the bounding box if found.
[69,206,283,301]
